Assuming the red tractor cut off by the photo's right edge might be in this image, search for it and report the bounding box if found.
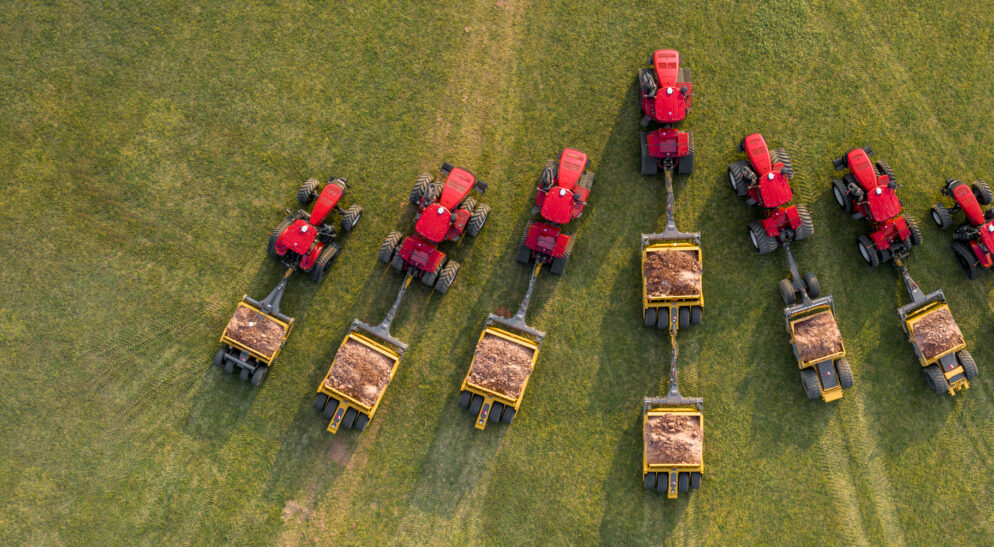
[932,179,994,279]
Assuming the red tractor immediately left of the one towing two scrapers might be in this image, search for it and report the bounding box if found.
[517,148,594,275]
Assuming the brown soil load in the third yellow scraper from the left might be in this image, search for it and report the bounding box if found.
[466,334,534,399]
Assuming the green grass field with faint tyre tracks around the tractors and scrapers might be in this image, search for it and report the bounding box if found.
[0,0,994,545]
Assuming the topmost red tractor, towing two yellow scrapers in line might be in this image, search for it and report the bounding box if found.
[638,49,694,175]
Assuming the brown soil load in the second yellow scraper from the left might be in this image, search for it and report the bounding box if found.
[324,339,393,407]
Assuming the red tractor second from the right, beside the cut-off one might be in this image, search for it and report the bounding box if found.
[832,146,922,266]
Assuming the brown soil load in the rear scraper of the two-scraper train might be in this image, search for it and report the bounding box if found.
[644,414,704,465]
